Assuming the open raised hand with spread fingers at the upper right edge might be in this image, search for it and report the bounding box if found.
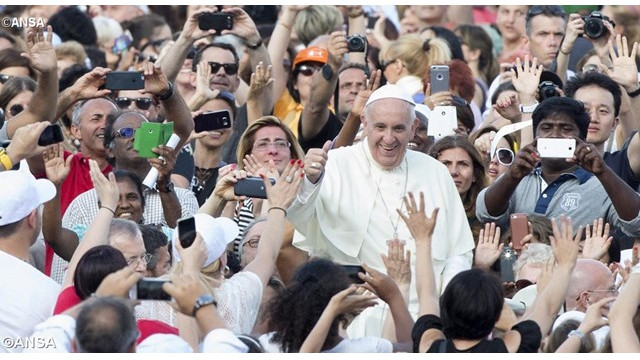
[602,34,639,92]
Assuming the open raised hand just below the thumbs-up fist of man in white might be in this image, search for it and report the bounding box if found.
[261,160,304,209]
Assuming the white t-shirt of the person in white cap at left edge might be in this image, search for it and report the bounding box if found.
[0,251,60,353]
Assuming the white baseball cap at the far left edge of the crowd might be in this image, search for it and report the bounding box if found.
[0,170,56,226]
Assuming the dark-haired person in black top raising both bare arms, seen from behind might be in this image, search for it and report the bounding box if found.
[400,193,582,353]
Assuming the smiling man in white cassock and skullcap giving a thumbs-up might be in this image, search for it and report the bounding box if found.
[288,85,474,337]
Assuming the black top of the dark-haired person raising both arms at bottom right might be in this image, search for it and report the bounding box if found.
[411,315,542,353]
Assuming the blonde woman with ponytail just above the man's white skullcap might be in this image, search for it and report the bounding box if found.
[380,34,451,103]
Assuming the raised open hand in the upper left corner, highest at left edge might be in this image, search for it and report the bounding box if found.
[20,25,58,73]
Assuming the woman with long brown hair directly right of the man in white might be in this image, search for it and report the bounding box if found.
[429,135,487,239]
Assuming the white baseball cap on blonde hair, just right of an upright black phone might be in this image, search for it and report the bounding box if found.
[173,214,240,268]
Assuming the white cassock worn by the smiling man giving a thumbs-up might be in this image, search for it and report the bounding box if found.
[287,139,474,338]
